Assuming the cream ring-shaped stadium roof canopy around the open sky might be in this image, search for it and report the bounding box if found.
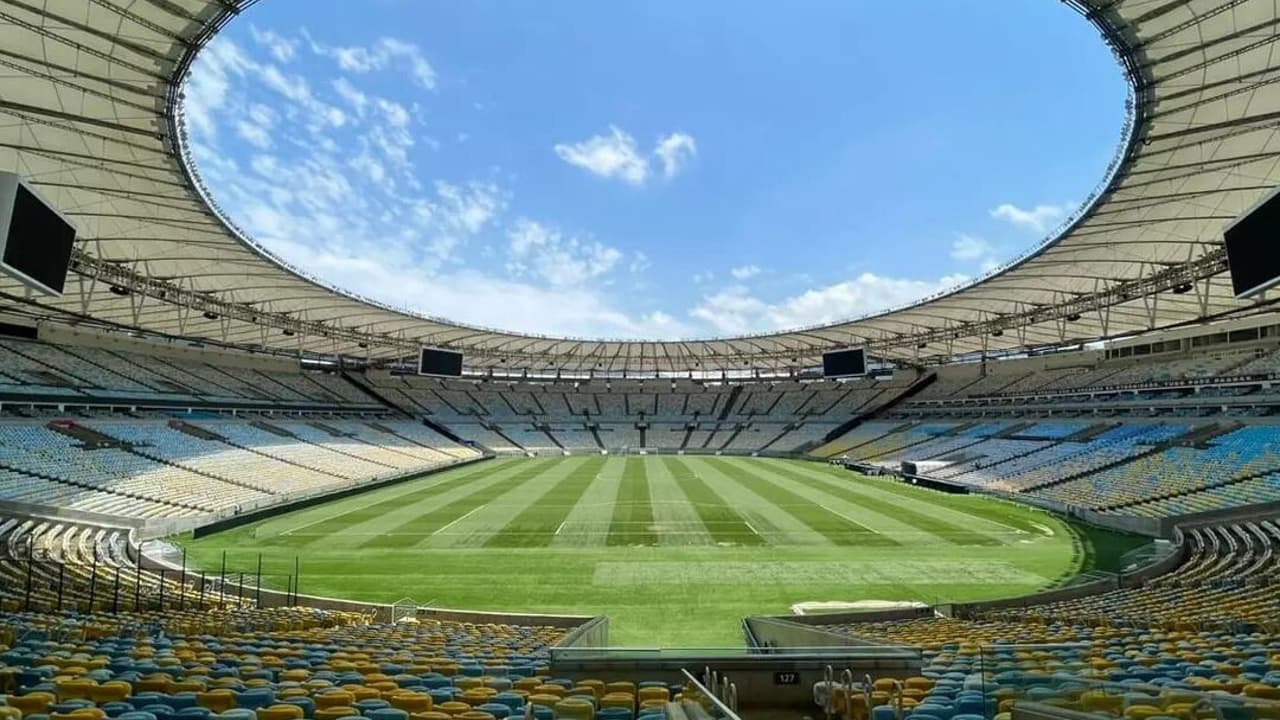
[0,0,1280,372]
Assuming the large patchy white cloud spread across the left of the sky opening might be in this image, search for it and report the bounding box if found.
[187,31,701,337]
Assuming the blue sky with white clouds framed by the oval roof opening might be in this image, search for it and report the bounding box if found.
[184,0,1126,340]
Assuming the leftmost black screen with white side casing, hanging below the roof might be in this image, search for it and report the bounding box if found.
[3,184,76,295]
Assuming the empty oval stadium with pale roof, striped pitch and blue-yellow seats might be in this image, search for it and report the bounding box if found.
[0,0,1280,720]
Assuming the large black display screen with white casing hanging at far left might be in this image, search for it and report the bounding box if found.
[0,173,76,295]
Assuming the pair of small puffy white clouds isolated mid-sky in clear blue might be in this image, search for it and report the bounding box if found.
[552,126,698,187]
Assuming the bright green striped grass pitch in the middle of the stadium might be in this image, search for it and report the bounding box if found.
[183,456,1123,647]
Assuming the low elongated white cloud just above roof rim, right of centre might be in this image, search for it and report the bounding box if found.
[690,273,969,334]
